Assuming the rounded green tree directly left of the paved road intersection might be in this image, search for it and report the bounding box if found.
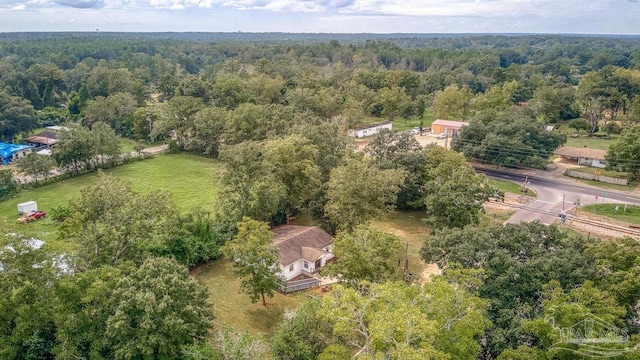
[422,145,503,228]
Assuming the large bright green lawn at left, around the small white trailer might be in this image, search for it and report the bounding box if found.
[0,154,219,240]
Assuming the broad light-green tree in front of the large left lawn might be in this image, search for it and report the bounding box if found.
[61,174,175,269]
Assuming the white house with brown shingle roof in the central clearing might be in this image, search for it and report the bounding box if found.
[273,225,333,281]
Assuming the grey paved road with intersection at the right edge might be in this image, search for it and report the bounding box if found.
[476,167,640,224]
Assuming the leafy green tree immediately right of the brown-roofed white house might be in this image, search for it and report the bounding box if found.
[322,226,400,287]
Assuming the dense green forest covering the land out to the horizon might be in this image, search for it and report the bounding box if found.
[0,32,640,360]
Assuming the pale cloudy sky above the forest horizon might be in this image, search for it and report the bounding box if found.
[0,0,640,35]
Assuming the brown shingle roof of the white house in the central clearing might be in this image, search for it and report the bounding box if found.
[273,225,333,266]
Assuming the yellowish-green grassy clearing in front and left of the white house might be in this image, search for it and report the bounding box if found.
[196,260,309,335]
